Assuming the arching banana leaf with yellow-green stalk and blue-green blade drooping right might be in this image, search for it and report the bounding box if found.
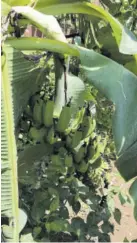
[7,38,137,178]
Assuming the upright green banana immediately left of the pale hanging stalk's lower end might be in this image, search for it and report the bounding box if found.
[42,100,54,127]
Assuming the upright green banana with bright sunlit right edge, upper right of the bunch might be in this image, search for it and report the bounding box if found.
[81,105,96,139]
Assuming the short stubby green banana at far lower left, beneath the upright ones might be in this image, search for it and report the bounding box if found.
[28,127,46,142]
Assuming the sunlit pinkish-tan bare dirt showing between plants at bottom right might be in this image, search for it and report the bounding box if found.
[69,167,137,242]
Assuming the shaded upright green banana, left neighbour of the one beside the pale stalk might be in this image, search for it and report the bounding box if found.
[33,99,43,125]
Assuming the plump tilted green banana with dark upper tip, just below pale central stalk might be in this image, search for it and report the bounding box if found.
[56,102,71,133]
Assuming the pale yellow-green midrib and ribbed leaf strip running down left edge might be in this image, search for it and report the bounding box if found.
[1,48,19,242]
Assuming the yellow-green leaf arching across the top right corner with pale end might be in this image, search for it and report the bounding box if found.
[36,0,137,54]
